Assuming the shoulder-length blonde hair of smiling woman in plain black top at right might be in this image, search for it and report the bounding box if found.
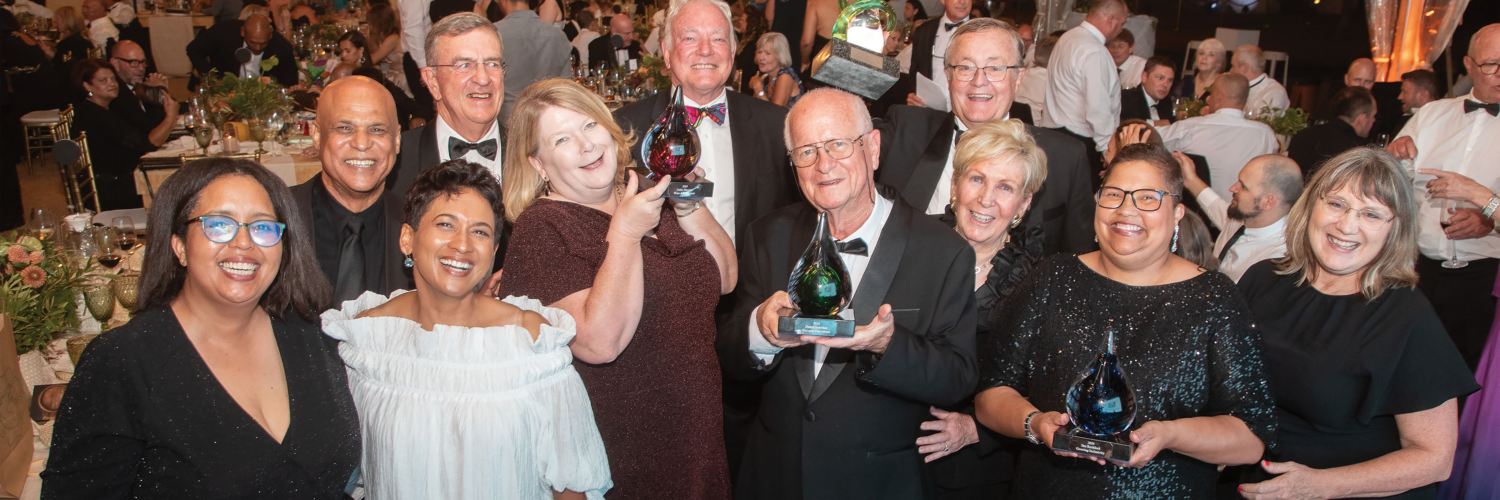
[1275,147,1418,300]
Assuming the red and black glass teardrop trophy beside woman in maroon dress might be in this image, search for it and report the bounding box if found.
[641,87,714,198]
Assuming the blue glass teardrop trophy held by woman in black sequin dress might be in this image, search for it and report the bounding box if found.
[1052,332,1136,462]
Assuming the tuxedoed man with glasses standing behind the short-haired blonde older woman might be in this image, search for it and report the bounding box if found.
[878,18,1094,254]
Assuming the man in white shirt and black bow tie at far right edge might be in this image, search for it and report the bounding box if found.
[1386,24,1500,369]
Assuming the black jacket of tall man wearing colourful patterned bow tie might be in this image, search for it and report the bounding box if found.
[612,92,803,242]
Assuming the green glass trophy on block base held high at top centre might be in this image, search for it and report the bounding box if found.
[812,0,902,99]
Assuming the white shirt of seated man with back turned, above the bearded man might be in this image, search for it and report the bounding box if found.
[1158,108,1278,198]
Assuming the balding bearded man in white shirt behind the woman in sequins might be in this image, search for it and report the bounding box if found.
[1173,153,1302,281]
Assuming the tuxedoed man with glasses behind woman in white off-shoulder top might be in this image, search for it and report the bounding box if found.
[386,12,510,280]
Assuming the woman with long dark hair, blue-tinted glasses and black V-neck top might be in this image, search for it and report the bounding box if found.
[42,159,360,498]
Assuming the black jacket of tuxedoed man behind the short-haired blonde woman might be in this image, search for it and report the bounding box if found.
[876,104,1095,255]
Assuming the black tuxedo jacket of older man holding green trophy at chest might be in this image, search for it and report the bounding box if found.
[716,186,978,500]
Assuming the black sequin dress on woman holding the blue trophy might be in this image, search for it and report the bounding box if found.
[980,255,1275,498]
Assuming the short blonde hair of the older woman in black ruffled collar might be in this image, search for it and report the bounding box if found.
[953,119,1047,197]
